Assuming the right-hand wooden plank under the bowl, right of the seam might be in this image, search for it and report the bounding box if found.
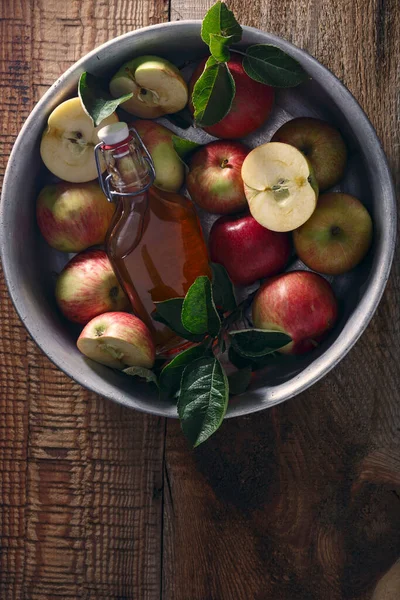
[163,0,400,600]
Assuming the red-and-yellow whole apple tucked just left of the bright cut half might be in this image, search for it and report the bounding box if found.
[186,140,250,214]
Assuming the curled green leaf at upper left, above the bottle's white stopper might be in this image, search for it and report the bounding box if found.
[78,72,133,127]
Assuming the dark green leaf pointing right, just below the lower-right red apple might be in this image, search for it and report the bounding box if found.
[229,329,292,358]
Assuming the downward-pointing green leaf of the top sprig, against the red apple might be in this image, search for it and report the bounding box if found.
[192,56,236,127]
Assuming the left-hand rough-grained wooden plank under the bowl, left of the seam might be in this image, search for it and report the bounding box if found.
[0,0,168,600]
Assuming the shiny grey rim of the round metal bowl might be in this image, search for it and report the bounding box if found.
[0,20,396,417]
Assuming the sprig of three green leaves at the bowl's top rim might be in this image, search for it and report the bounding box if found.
[192,2,308,127]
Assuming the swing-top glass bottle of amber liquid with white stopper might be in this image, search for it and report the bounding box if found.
[96,122,211,356]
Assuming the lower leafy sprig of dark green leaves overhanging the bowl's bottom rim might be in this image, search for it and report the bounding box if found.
[125,264,291,447]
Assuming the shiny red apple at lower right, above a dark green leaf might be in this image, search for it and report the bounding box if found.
[252,271,337,354]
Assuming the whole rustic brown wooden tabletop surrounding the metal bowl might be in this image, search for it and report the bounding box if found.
[0,0,400,600]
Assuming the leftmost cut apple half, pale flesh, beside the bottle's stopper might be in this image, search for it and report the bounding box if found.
[40,98,118,183]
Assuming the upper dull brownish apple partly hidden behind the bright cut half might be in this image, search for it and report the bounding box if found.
[272,117,347,191]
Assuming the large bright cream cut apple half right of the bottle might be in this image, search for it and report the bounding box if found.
[242,142,318,231]
